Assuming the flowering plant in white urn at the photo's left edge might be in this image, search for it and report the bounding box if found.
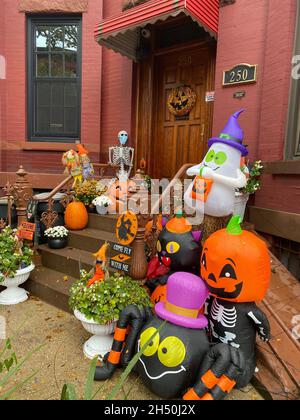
[0,227,34,305]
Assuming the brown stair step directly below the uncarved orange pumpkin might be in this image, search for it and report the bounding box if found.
[69,228,117,253]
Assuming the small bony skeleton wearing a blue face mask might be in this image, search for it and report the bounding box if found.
[109,131,134,181]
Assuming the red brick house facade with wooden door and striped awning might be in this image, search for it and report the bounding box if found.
[0,0,300,274]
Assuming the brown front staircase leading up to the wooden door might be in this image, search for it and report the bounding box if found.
[26,214,117,311]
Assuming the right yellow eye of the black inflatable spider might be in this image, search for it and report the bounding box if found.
[158,337,186,368]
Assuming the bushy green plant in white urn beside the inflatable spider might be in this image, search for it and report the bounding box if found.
[69,271,151,359]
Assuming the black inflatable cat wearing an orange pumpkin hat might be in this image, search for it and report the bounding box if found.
[147,212,202,303]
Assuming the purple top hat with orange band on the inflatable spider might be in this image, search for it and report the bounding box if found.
[155,272,209,329]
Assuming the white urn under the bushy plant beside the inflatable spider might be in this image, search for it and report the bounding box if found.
[74,309,117,359]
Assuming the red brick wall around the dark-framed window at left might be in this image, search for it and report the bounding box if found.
[0,0,103,172]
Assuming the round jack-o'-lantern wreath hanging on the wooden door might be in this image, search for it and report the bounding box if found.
[168,86,197,117]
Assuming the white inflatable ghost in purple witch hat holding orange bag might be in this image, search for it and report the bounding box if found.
[184,110,248,217]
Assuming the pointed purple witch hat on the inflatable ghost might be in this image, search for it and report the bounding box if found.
[208,109,248,157]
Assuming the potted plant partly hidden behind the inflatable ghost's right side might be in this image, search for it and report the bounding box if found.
[234,160,264,220]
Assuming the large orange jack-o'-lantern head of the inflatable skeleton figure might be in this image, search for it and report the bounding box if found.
[201,216,271,302]
